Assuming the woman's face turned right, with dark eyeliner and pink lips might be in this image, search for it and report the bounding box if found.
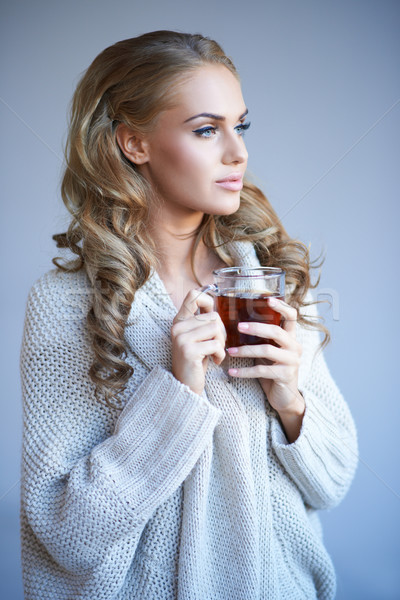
[138,65,247,218]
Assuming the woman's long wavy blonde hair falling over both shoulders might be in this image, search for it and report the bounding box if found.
[53,31,328,403]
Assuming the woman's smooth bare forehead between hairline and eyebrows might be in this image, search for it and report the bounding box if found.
[168,65,246,119]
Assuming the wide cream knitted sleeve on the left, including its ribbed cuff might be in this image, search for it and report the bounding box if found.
[21,272,220,598]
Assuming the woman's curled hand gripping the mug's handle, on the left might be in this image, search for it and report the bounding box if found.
[171,290,226,395]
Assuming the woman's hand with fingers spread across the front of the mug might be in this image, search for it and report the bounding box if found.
[228,298,305,442]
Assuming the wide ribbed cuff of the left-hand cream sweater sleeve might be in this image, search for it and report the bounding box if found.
[93,366,221,514]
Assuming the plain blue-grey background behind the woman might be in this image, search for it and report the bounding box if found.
[0,0,400,600]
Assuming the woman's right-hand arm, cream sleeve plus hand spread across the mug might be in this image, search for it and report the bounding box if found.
[228,296,357,508]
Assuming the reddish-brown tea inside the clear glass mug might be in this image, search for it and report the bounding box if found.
[215,291,283,348]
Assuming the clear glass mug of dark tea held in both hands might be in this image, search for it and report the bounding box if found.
[201,267,285,348]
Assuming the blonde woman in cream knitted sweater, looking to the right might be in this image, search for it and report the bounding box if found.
[21,31,357,600]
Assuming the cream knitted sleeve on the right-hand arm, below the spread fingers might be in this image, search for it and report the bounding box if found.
[272,298,358,509]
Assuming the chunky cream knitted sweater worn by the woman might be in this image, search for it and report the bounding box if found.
[21,243,357,600]
